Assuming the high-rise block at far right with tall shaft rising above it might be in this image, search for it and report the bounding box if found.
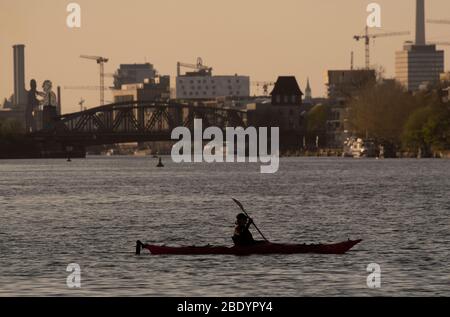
[395,0,444,91]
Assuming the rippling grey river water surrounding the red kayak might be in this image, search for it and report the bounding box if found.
[0,158,450,296]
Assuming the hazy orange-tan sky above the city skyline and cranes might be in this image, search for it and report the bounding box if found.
[0,0,450,112]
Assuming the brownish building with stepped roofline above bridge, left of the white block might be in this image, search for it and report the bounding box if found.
[113,76,170,103]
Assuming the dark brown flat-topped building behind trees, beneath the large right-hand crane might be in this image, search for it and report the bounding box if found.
[326,69,376,104]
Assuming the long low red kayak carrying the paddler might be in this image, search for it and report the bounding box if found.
[136,240,362,256]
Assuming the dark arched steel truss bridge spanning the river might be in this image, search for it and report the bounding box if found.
[32,101,247,147]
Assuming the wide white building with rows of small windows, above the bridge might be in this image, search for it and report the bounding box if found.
[176,70,250,100]
